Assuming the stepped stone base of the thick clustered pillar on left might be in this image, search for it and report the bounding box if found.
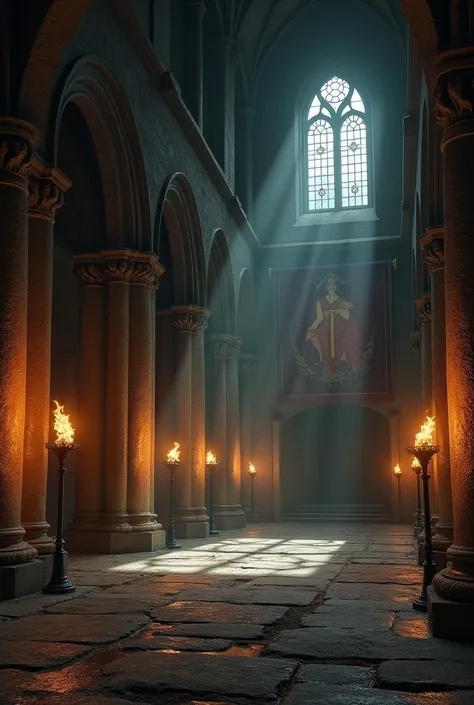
[65,525,166,554]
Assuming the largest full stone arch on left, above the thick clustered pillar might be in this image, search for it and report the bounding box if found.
[51,57,152,251]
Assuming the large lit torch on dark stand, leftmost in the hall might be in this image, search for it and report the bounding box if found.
[43,401,79,595]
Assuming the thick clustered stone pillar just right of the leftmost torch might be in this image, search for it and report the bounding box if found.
[68,250,164,553]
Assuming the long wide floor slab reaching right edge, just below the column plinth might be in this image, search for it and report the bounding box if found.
[269,627,474,662]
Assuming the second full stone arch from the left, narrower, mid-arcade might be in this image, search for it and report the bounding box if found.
[153,172,206,306]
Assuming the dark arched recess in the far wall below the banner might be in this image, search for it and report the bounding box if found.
[280,405,391,520]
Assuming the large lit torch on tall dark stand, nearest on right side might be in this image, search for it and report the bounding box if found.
[407,416,439,612]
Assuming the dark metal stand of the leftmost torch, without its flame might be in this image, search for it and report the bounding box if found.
[43,443,78,595]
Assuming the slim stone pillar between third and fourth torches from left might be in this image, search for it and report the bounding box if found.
[211,335,245,529]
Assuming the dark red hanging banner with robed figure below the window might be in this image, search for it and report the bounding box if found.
[273,262,392,404]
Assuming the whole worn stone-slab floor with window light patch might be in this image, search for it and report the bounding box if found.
[0,524,474,705]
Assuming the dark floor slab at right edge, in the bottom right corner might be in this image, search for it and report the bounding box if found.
[377,660,474,688]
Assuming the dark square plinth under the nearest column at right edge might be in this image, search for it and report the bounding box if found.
[428,586,474,641]
